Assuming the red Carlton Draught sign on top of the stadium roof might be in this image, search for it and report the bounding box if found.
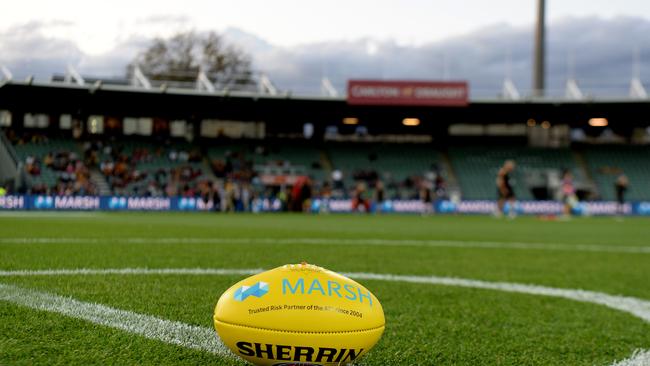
[348,80,469,106]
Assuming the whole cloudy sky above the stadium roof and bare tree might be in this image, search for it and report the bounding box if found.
[0,0,650,95]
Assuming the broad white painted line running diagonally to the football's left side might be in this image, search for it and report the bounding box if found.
[0,283,232,357]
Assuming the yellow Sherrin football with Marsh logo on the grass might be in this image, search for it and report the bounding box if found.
[214,263,385,366]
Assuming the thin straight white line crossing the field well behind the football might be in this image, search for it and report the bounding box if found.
[0,237,650,254]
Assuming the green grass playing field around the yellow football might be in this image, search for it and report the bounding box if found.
[0,213,650,365]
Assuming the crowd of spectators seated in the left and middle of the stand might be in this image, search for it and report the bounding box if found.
[2,131,444,211]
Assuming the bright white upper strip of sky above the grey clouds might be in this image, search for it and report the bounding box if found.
[0,0,650,54]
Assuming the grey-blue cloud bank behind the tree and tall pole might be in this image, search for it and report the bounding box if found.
[0,16,650,96]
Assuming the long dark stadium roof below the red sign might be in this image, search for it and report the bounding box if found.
[0,81,650,133]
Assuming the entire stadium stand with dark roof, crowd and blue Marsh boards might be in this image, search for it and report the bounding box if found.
[0,76,650,214]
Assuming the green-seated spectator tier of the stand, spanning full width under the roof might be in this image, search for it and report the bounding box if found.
[7,124,650,206]
